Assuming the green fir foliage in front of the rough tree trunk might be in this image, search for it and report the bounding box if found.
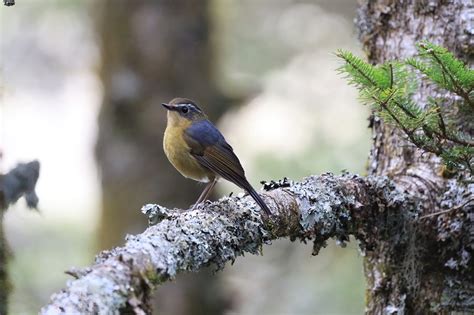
[336,42,474,176]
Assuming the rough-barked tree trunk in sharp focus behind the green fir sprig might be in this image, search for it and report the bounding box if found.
[357,0,474,314]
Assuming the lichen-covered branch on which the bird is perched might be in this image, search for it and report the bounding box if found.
[41,174,406,314]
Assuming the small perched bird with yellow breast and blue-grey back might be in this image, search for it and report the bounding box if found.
[161,98,271,215]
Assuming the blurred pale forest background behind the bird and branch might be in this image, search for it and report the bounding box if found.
[0,0,370,314]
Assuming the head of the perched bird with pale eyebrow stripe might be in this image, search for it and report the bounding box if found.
[161,97,207,125]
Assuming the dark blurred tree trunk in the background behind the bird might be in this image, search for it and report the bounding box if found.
[94,0,231,314]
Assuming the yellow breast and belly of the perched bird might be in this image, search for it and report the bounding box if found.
[163,124,211,182]
